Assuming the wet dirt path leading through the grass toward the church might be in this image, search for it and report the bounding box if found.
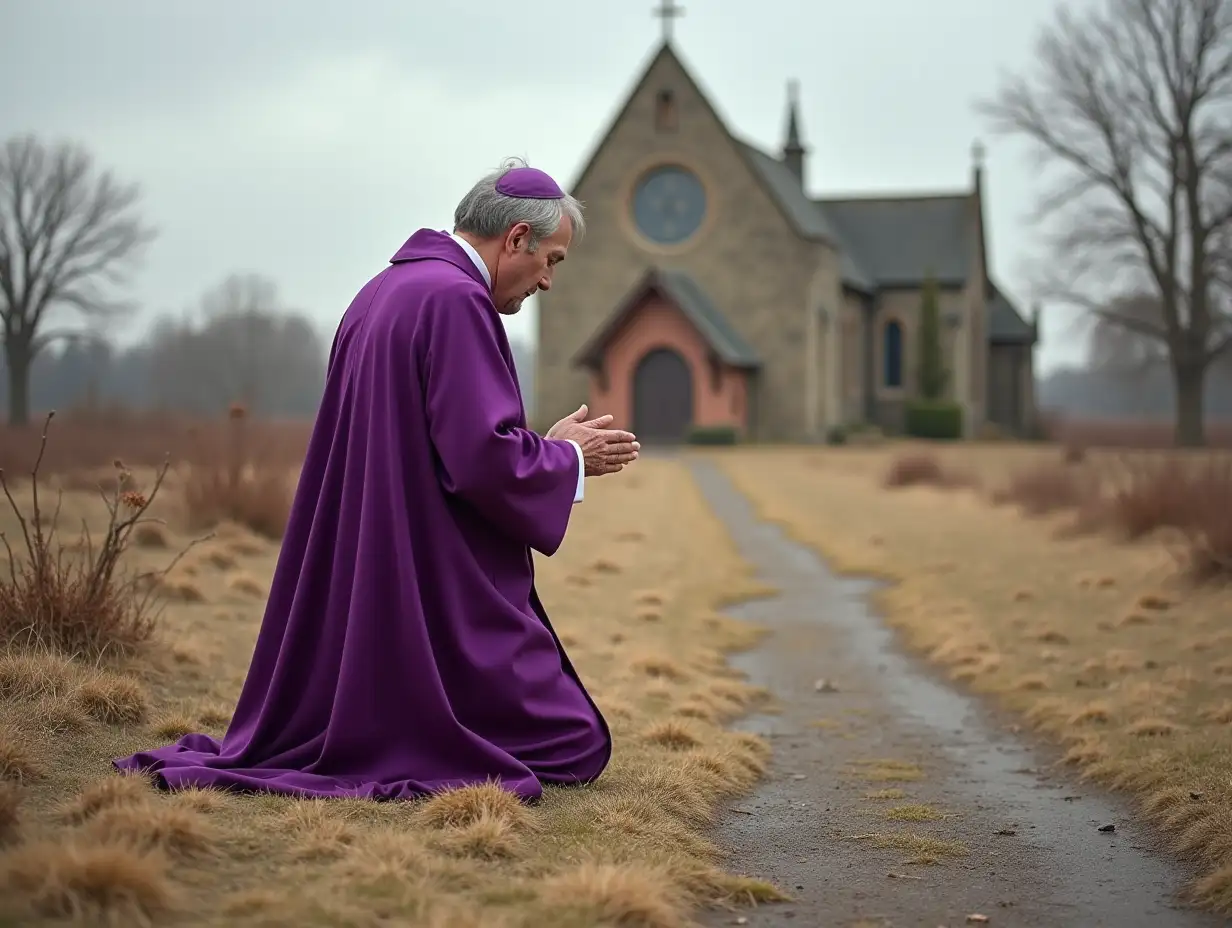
[692,460,1223,928]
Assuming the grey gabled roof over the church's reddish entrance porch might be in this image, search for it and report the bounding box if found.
[574,267,761,367]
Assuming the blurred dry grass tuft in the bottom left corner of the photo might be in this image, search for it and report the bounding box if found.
[0,840,176,926]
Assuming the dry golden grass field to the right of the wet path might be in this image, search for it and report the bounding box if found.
[715,442,1232,914]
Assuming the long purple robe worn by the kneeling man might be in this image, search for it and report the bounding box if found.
[115,229,611,801]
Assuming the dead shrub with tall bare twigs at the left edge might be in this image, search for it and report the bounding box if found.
[0,413,202,657]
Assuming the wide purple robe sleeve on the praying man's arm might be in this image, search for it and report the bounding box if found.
[423,288,582,556]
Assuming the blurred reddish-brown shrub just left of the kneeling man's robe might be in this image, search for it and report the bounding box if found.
[182,405,292,541]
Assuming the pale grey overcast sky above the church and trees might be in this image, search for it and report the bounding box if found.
[0,0,1084,367]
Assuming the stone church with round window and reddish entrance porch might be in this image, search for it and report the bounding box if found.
[535,41,1037,442]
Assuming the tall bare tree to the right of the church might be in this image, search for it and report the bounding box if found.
[979,0,1232,445]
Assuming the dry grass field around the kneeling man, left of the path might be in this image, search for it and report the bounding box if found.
[0,410,777,928]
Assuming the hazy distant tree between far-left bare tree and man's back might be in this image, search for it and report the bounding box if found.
[149,274,325,414]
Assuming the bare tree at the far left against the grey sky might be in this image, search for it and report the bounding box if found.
[0,136,154,425]
